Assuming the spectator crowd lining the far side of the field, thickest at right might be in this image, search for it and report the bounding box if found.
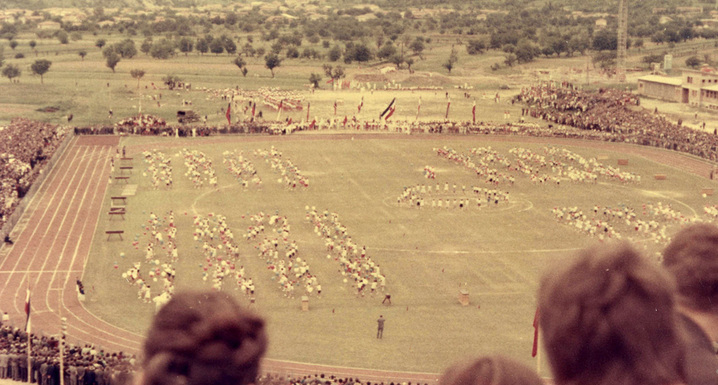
[67,82,718,166]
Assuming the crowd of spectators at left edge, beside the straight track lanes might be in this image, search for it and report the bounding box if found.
[0,118,65,227]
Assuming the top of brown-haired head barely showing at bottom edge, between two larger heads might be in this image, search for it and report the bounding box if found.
[439,356,543,385]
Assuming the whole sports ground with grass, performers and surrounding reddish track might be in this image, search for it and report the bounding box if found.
[1,87,715,381]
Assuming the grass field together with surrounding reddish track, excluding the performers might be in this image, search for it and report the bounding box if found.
[0,133,716,378]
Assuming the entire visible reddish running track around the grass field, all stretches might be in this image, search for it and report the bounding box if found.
[0,131,711,383]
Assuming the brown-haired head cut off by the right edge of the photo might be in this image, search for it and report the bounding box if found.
[663,223,718,313]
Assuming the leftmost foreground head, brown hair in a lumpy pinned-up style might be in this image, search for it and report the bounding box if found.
[142,292,267,385]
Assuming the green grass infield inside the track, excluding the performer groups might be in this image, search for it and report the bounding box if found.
[84,134,716,373]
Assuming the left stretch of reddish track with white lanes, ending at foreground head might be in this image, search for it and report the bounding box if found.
[0,137,142,352]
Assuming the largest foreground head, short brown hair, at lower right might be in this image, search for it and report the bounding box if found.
[539,243,685,385]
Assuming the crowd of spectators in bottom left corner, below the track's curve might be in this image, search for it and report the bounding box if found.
[0,325,136,385]
